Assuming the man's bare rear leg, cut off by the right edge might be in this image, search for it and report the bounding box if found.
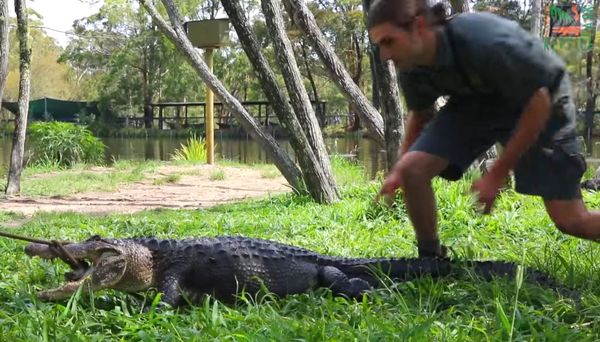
[544,199,600,242]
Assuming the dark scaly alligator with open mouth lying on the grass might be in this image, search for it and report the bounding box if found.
[25,235,555,307]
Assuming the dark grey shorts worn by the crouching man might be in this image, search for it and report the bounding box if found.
[410,94,587,200]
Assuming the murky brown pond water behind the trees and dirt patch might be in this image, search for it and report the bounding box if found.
[0,136,385,177]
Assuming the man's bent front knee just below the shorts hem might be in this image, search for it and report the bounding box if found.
[398,152,448,185]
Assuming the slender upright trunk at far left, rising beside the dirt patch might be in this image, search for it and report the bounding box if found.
[6,0,31,195]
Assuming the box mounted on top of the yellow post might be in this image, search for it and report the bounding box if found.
[183,18,230,49]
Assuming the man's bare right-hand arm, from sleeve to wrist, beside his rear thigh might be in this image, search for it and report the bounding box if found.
[490,87,552,178]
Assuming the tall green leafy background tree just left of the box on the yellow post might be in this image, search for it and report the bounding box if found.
[61,0,202,120]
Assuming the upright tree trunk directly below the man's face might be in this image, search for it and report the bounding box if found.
[363,0,404,170]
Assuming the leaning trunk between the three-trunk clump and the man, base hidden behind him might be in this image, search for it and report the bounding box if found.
[283,0,385,146]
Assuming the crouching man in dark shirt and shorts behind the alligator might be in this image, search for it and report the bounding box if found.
[368,0,600,257]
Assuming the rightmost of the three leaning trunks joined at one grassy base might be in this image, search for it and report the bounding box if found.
[262,0,339,202]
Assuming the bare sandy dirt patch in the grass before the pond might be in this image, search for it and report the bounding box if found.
[0,165,291,216]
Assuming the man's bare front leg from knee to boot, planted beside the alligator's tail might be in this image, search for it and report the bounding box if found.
[398,151,448,256]
